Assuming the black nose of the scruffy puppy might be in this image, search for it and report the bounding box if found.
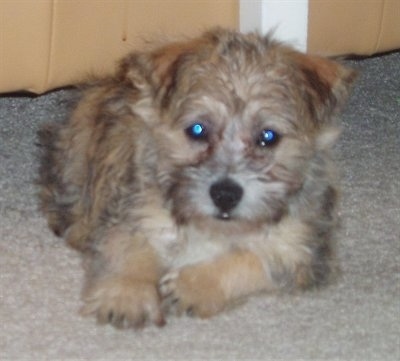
[210,178,243,213]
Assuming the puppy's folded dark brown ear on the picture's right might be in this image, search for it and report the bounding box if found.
[290,52,356,123]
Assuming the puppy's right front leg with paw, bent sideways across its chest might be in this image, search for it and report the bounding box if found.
[160,250,272,318]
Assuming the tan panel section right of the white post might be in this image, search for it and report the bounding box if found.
[307,0,400,55]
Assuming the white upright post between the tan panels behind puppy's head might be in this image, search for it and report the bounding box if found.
[239,0,308,51]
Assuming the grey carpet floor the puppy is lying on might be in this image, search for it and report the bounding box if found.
[0,52,400,361]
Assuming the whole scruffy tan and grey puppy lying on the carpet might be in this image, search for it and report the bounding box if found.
[40,29,354,328]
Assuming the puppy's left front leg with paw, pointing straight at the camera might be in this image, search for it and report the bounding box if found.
[82,230,165,328]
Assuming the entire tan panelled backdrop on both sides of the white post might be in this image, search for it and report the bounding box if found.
[0,0,400,93]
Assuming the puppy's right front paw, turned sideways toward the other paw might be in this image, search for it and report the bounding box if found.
[159,265,226,318]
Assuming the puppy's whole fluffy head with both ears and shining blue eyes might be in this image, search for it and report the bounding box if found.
[121,29,354,231]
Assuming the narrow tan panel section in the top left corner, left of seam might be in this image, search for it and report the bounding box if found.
[0,0,53,91]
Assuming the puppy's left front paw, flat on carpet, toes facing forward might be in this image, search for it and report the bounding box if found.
[81,277,165,328]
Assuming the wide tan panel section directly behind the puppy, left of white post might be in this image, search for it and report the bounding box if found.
[40,0,237,93]
